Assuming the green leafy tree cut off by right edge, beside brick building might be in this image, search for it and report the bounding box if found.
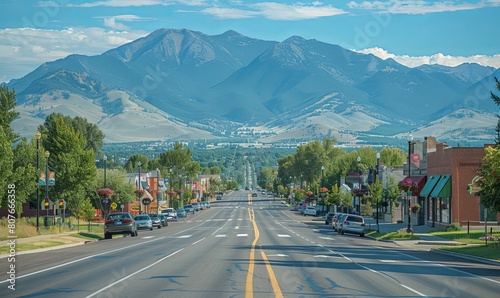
[477,147,500,212]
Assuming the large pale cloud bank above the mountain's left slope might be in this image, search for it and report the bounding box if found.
[0,28,149,82]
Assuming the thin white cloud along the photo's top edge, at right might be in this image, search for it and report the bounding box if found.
[347,0,500,14]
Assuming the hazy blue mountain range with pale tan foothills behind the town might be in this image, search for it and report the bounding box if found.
[8,29,500,144]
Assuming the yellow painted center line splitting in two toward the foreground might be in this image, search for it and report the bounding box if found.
[245,208,283,298]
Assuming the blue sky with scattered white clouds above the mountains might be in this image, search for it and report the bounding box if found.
[0,0,500,82]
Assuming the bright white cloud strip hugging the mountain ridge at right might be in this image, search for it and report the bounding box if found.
[356,48,500,68]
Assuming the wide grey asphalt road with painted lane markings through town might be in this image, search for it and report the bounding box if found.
[0,191,500,298]
